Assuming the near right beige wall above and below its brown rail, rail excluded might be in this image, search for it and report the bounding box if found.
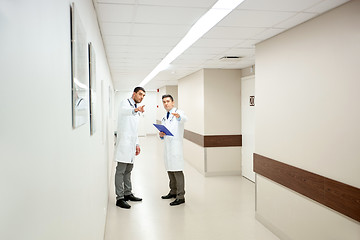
[255,0,360,239]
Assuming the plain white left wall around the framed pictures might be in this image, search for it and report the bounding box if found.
[0,0,112,240]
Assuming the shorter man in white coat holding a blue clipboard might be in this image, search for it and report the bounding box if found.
[159,95,187,206]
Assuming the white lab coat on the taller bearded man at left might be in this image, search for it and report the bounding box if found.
[115,99,140,163]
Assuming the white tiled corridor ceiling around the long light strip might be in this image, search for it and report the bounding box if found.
[93,0,347,91]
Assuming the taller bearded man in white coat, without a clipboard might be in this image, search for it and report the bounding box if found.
[115,87,145,209]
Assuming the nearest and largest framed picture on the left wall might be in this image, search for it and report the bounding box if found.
[70,3,89,128]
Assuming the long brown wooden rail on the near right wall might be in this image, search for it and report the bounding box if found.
[254,153,360,221]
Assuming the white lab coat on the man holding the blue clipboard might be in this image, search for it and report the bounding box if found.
[161,108,187,172]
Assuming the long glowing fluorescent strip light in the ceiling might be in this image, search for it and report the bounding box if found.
[139,0,244,87]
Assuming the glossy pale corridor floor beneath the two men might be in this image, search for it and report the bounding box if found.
[105,136,278,240]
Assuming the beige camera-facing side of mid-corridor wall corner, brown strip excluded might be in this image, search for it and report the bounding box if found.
[204,69,241,175]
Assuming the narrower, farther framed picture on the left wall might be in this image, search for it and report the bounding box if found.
[88,43,96,135]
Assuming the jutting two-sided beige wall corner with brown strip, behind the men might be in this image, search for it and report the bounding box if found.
[178,69,241,176]
